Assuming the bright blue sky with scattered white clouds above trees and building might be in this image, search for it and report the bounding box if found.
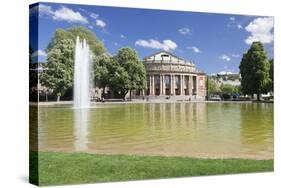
[30,3,273,74]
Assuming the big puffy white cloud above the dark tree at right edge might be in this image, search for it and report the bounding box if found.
[245,17,274,44]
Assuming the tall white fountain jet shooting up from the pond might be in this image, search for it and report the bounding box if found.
[74,36,92,108]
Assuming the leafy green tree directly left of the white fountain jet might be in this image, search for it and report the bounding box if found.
[40,39,74,101]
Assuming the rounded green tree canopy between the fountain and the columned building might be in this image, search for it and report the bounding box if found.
[95,47,146,98]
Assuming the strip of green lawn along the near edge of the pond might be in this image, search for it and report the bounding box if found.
[30,152,273,186]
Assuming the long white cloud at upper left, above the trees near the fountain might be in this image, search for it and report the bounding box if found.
[53,7,88,24]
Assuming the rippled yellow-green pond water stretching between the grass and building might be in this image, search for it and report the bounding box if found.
[31,103,273,159]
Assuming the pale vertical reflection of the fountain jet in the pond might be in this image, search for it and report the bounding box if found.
[74,108,89,151]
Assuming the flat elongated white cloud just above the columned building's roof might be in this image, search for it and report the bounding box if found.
[135,39,178,51]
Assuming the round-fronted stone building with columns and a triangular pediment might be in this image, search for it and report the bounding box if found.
[143,51,206,99]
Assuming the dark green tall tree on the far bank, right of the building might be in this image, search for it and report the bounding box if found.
[239,42,270,100]
